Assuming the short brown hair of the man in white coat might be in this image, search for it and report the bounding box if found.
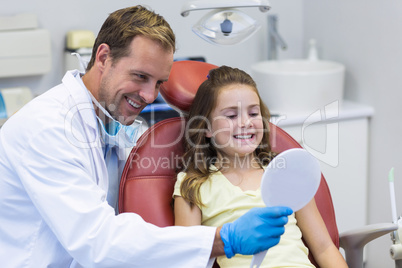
[87,5,176,71]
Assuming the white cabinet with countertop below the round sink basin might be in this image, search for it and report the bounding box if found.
[271,101,373,232]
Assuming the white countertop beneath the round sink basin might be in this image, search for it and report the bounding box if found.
[271,100,374,127]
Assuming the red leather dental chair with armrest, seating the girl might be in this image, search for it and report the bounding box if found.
[119,61,397,268]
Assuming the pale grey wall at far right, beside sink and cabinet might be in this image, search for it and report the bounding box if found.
[303,0,402,268]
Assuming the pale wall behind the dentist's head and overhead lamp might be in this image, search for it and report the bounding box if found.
[0,0,302,94]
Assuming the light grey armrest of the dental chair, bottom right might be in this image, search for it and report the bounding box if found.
[339,223,398,268]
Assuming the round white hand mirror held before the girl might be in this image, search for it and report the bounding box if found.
[261,148,321,212]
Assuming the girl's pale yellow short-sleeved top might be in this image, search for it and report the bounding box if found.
[173,166,314,268]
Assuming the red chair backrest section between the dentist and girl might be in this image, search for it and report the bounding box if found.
[119,117,185,227]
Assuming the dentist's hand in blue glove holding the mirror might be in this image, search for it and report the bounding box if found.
[220,207,293,258]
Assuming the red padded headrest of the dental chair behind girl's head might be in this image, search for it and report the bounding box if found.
[160,61,218,112]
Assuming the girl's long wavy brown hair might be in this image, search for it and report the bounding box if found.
[180,66,276,207]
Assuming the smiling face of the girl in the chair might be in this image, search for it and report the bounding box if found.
[206,84,264,157]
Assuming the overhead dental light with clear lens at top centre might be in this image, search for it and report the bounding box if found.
[181,0,271,45]
